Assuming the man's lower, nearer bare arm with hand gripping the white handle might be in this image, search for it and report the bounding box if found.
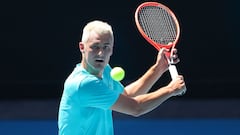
[111,76,185,116]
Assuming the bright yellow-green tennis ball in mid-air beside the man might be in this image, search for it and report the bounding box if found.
[110,67,125,81]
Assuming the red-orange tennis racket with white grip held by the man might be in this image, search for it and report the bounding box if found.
[135,2,186,94]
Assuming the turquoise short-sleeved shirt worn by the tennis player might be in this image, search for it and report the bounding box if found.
[58,64,124,135]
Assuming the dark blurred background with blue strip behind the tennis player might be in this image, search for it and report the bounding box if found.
[0,0,240,135]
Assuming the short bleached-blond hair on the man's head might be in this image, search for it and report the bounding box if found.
[81,20,113,43]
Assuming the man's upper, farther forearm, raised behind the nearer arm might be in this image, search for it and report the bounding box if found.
[125,65,165,97]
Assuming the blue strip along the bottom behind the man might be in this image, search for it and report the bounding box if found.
[0,118,240,135]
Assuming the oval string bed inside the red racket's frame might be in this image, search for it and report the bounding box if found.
[138,6,177,45]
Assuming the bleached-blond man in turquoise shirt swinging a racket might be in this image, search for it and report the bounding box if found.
[58,20,185,135]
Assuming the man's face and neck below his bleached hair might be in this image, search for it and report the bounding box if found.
[80,31,113,77]
